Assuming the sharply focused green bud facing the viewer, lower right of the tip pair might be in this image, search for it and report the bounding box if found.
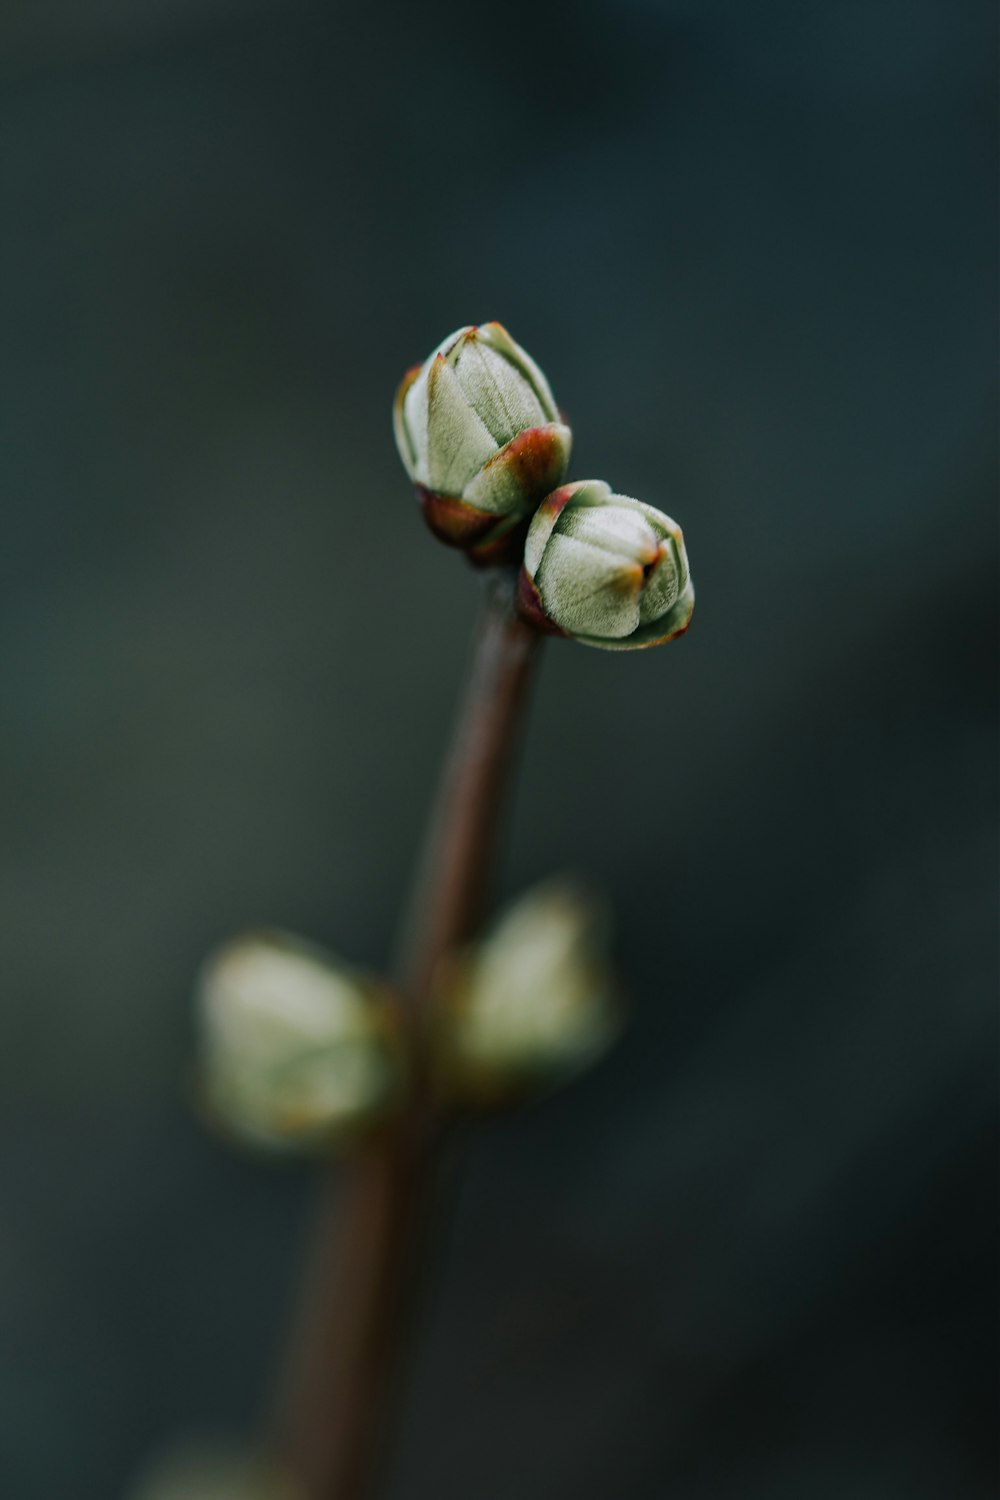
[517,479,694,651]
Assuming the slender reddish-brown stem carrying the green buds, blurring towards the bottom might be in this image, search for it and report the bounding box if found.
[269,570,540,1500]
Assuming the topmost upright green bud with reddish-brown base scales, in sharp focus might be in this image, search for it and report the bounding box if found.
[393,323,571,563]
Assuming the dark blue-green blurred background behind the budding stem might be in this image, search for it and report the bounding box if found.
[0,0,997,1500]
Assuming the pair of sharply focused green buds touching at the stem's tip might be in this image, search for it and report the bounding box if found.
[394,323,694,651]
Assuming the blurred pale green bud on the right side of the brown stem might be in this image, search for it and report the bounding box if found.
[438,881,619,1103]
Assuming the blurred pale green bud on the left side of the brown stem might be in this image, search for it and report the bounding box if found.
[195,932,400,1152]
